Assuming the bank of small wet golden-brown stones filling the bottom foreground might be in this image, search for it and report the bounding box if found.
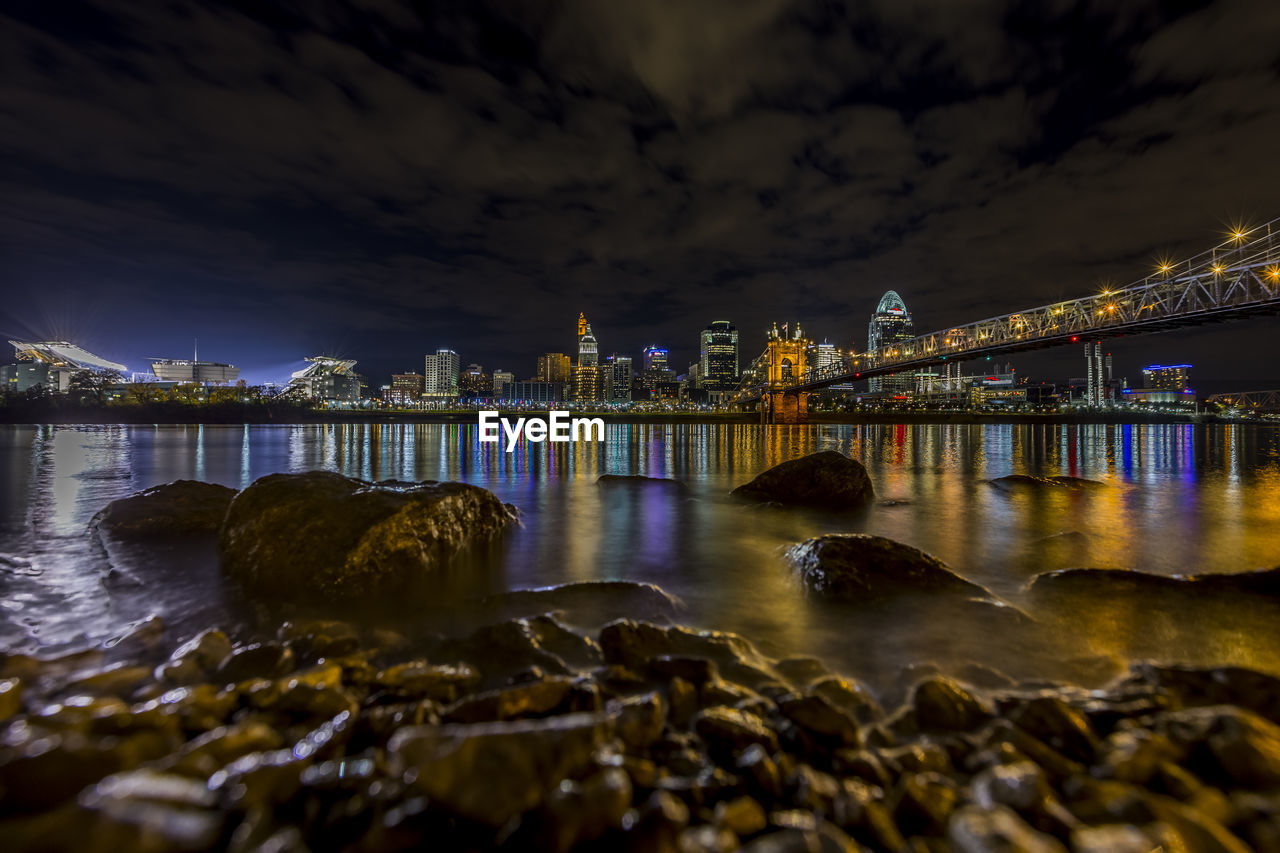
[0,615,1280,852]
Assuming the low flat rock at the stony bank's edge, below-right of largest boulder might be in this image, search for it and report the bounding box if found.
[480,580,685,626]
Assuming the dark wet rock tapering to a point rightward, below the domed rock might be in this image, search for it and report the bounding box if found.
[787,533,995,602]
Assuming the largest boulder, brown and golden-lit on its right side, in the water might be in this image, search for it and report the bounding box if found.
[219,471,515,601]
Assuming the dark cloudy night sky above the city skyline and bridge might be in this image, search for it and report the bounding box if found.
[0,0,1280,391]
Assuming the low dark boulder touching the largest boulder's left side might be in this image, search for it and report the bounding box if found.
[90,480,236,538]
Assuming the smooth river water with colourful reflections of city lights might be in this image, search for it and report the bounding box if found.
[0,424,1280,693]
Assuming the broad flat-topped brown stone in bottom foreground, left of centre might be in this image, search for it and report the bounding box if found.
[387,713,609,826]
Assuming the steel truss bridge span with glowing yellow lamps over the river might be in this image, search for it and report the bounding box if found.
[730,212,1280,403]
